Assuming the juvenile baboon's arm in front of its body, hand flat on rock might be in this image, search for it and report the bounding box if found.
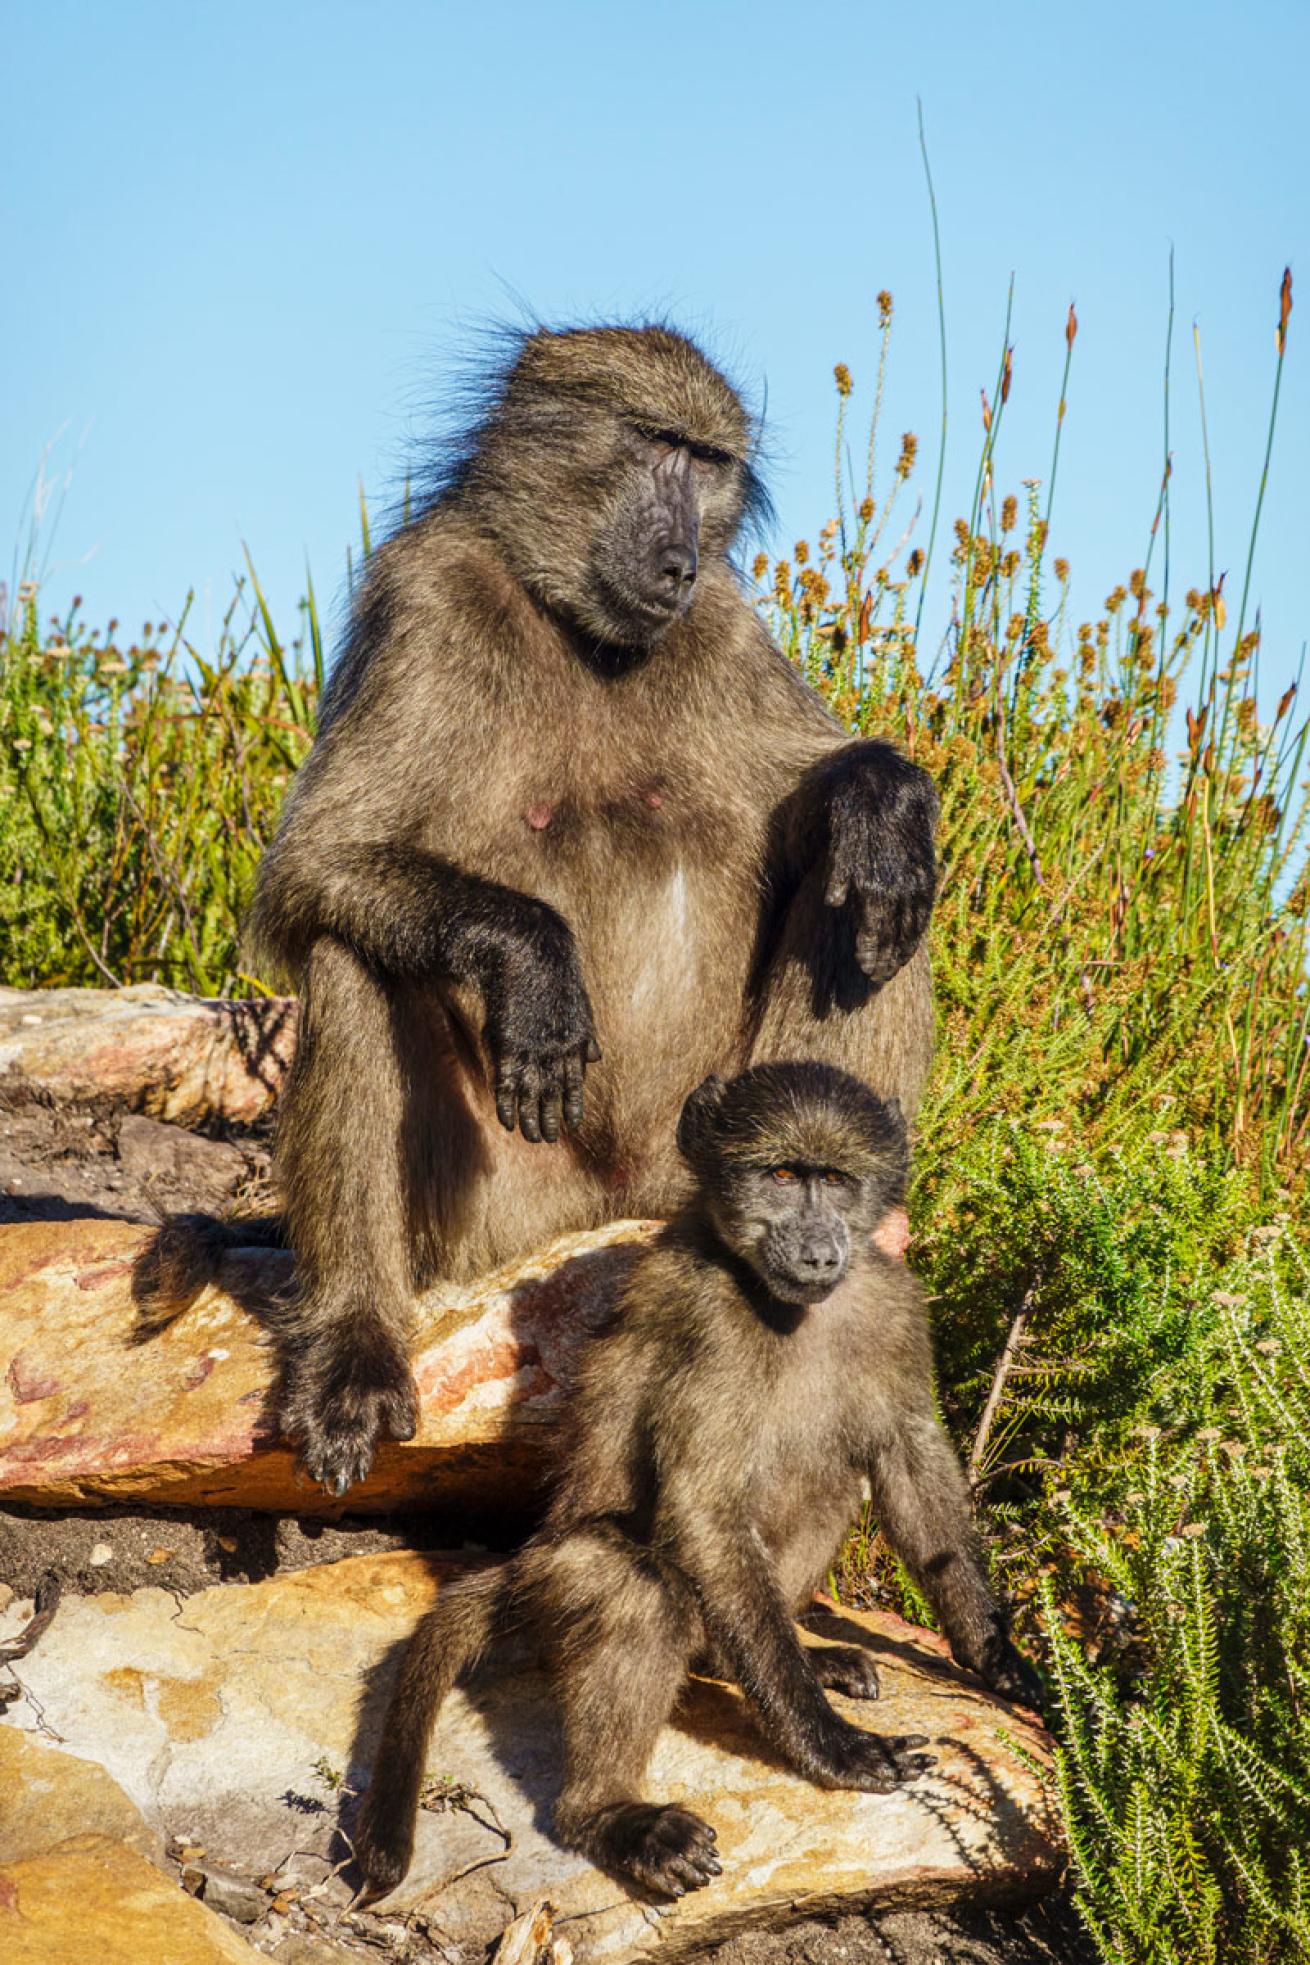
[656,1491,931,1794]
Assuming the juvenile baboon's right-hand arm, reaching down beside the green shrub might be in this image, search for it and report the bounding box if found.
[868,1407,1041,1710]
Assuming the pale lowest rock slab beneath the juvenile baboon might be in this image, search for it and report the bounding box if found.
[0,1554,1059,1965]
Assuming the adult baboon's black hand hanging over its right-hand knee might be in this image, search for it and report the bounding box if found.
[823,743,937,984]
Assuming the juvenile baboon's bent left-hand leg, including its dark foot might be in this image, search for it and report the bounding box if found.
[540,1531,721,1896]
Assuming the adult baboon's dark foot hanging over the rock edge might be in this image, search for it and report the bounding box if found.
[281,1330,418,1495]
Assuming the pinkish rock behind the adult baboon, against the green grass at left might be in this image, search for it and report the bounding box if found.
[0,983,297,1126]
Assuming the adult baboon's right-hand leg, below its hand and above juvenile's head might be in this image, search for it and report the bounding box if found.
[744,867,933,1120]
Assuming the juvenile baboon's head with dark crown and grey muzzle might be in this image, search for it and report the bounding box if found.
[678,1061,907,1303]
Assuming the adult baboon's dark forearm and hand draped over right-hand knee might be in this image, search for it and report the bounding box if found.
[772,739,937,984]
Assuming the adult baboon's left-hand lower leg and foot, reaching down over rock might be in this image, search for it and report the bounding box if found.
[277,939,416,1493]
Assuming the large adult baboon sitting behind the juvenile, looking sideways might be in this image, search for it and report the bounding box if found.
[139,326,935,1493]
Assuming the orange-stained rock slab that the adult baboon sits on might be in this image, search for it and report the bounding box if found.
[0,1220,652,1515]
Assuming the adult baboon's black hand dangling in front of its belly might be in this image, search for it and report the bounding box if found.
[485,904,601,1142]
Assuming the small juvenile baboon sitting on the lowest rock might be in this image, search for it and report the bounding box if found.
[355,1063,1039,1896]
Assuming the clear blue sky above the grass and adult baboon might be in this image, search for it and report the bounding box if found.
[0,0,1310,688]
